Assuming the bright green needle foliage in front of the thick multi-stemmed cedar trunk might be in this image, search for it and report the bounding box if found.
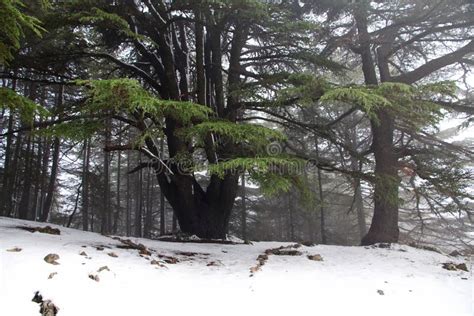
[75,79,304,194]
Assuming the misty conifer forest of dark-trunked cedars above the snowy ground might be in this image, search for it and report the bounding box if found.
[0,0,474,249]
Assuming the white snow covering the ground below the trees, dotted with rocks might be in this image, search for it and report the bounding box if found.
[0,218,473,316]
